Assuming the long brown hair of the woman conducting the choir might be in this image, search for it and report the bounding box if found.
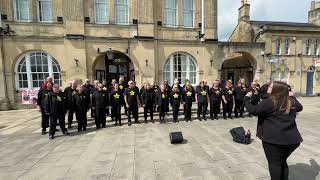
[270,81,293,113]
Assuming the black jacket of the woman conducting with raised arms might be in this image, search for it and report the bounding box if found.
[244,97,303,145]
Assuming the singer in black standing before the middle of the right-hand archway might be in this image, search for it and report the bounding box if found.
[234,81,247,118]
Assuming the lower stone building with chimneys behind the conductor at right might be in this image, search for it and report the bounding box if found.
[229,0,320,96]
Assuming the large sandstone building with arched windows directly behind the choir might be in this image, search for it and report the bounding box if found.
[0,0,267,109]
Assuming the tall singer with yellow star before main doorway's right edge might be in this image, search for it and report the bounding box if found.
[124,81,140,126]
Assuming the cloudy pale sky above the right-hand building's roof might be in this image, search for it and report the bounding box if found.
[218,0,311,40]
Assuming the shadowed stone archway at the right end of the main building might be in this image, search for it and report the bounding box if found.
[220,53,255,85]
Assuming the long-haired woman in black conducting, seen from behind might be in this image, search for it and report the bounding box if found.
[244,81,303,180]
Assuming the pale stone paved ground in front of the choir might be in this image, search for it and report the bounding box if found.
[0,98,320,180]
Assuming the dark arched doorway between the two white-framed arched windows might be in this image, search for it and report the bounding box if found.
[93,50,135,83]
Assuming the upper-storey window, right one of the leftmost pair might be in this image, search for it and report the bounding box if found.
[38,0,53,22]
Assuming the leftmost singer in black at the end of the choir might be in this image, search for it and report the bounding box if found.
[37,81,53,135]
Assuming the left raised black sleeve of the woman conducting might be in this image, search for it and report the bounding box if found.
[244,96,273,116]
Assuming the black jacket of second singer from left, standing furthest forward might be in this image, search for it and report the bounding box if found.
[44,91,67,117]
